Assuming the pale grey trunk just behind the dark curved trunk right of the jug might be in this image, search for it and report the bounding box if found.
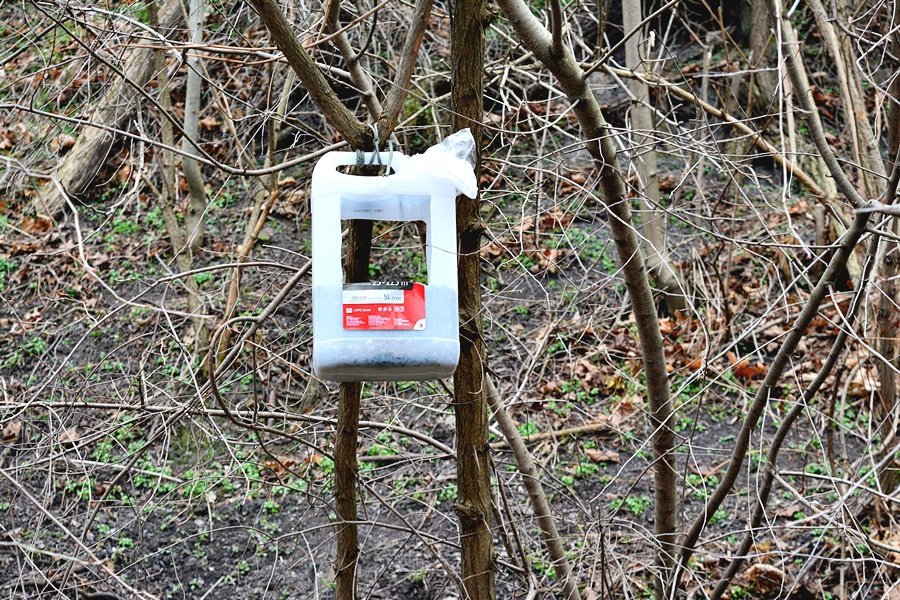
[622,0,688,314]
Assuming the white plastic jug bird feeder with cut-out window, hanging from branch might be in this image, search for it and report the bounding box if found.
[312,129,477,381]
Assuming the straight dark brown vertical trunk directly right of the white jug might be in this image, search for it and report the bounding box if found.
[450,0,496,600]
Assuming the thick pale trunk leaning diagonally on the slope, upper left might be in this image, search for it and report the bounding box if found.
[32,0,184,217]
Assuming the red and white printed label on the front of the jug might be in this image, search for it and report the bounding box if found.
[342,281,425,331]
